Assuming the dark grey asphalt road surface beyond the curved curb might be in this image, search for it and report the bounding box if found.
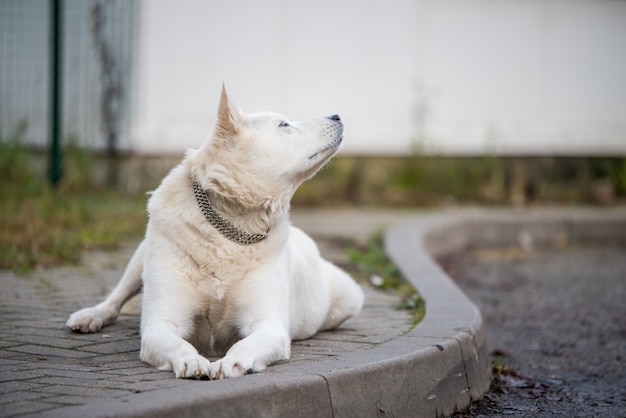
[439,246,626,417]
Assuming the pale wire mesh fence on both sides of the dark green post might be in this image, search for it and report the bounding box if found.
[0,0,138,149]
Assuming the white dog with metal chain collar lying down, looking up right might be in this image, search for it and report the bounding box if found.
[67,88,363,379]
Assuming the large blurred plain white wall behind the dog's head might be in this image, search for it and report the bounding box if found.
[127,0,626,155]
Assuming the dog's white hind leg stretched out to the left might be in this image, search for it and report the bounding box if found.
[66,241,146,333]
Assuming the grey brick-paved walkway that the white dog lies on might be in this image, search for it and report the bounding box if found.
[0,211,411,417]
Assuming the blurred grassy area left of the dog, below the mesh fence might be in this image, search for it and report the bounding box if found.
[0,136,147,271]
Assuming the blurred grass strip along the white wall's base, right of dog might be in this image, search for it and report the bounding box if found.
[293,154,626,207]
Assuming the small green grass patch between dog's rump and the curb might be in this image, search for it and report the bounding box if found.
[349,233,426,326]
